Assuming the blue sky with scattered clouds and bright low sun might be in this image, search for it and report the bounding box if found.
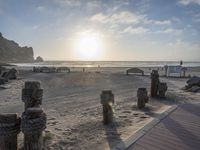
[0,0,200,61]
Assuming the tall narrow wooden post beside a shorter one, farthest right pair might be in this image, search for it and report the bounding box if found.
[151,70,159,97]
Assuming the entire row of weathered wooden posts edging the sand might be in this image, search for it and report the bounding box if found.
[0,71,167,150]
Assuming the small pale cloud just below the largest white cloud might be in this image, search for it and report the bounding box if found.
[122,26,149,34]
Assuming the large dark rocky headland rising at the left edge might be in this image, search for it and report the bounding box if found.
[0,33,34,62]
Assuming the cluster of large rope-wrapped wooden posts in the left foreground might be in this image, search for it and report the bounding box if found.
[0,81,47,150]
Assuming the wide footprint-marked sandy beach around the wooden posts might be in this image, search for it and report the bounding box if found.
[0,68,200,150]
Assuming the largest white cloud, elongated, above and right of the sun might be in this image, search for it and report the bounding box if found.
[90,11,144,24]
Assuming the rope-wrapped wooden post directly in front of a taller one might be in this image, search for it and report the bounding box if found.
[21,108,46,150]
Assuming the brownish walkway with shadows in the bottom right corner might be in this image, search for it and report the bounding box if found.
[127,104,200,150]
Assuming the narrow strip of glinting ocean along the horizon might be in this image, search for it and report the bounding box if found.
[11,61,200,67]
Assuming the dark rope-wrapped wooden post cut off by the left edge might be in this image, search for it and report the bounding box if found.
[0,114,21,150]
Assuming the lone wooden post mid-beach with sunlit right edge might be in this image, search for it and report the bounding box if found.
[101,90,114,124]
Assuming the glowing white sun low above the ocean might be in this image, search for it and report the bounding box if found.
[74,33,102,60]
